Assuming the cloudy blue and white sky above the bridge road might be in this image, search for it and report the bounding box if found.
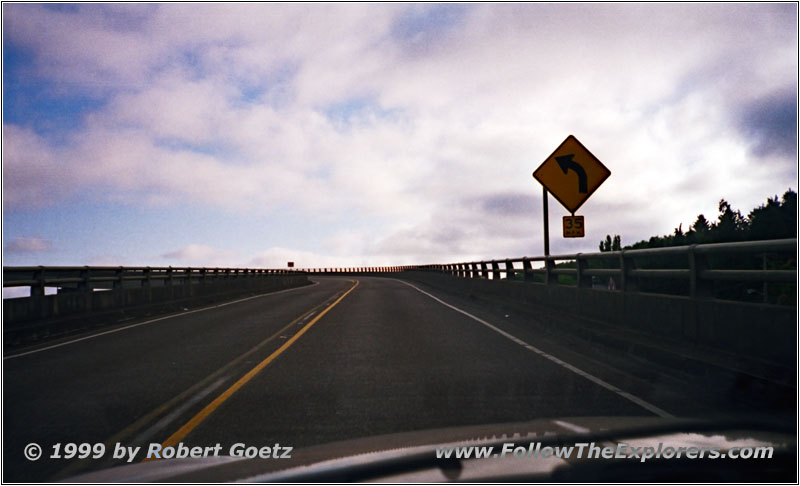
[2,3,798,274]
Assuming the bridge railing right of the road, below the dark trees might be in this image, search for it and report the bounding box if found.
[408,238,797,303]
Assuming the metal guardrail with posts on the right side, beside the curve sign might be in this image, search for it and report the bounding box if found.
[411,238,797,300]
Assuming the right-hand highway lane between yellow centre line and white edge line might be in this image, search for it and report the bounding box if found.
[155,278,653,460]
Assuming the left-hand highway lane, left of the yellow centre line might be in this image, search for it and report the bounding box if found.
[3,280,349,481]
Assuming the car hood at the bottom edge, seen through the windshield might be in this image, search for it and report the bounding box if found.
[67,417,796,483]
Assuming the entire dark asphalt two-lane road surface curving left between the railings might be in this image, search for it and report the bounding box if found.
[3,277,764,482]
